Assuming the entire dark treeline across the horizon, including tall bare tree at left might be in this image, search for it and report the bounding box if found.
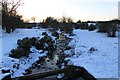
[1,0,120,37]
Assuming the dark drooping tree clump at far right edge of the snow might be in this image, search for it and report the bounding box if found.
[96,19,120,37]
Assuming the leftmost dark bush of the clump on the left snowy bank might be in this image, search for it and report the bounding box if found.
[9,37,32,58]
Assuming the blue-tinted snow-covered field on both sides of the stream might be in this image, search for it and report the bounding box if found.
[0,29,118,79]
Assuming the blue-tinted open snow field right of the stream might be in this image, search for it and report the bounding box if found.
[70,30,118,78]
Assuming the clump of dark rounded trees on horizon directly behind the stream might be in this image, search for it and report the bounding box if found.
[40,17,74,35]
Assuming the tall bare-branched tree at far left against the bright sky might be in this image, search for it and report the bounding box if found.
[1,0,23,33]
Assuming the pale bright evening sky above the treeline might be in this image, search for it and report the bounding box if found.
[18,0,119,22]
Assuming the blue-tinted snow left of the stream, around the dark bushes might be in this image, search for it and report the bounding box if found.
[0,29,48,79]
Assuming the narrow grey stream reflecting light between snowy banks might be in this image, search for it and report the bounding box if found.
[32,35,69,78]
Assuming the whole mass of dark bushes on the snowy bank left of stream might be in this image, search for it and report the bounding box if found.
[9,32,56,58]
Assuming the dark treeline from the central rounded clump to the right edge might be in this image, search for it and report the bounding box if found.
[40,17,120,37]
